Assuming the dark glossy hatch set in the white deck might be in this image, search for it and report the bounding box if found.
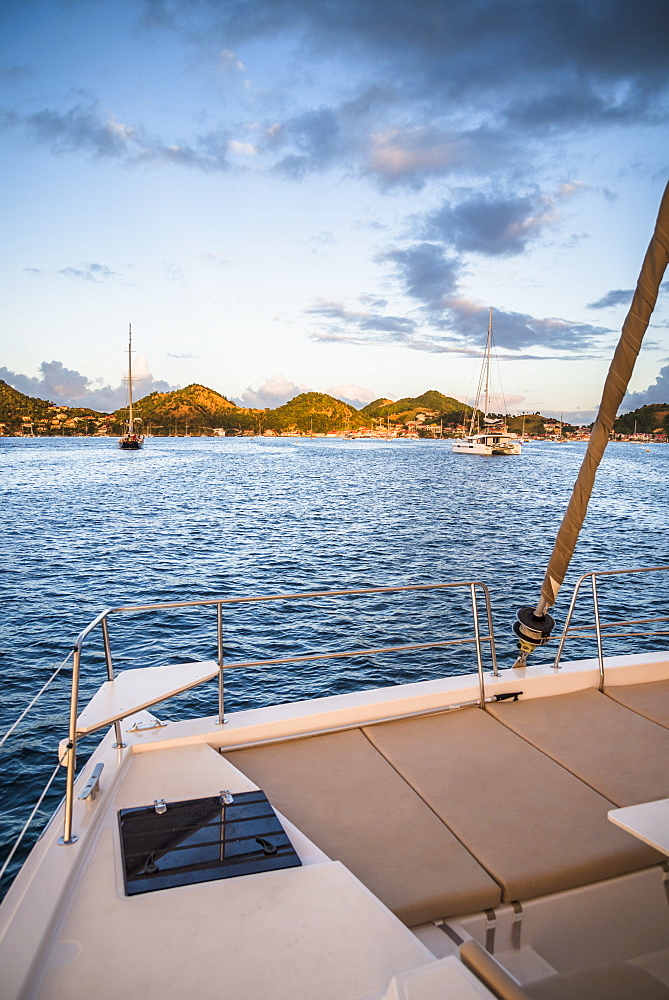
[118,790,301,896]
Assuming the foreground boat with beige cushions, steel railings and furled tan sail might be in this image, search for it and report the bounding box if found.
[0,185,669,1000]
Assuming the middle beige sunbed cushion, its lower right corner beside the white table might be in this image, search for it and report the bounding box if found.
[365,699,659,901]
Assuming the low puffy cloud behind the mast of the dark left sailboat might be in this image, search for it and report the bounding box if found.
[0,354,178,413]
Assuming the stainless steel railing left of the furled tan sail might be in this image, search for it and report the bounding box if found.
[59,580,499,844]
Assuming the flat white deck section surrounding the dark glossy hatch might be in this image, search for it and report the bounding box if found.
[3,746,486,1000]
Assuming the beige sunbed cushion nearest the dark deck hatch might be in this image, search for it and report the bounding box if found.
[226,729,500,925]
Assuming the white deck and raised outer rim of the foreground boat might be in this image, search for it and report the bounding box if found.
[0,654,669,1000]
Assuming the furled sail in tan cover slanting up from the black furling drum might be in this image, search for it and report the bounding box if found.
[536,184,669,614]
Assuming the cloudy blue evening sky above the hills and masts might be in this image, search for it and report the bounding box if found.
[0,0,669,422]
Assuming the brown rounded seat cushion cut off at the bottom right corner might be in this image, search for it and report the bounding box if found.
[524,965,669,1000]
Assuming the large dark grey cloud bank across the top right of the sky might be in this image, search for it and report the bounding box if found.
[145,0,669,138]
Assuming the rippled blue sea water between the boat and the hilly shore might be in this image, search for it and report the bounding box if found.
[0,438,669,892]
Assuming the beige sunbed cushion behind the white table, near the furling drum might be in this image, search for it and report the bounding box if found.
[489,688,669,806]
